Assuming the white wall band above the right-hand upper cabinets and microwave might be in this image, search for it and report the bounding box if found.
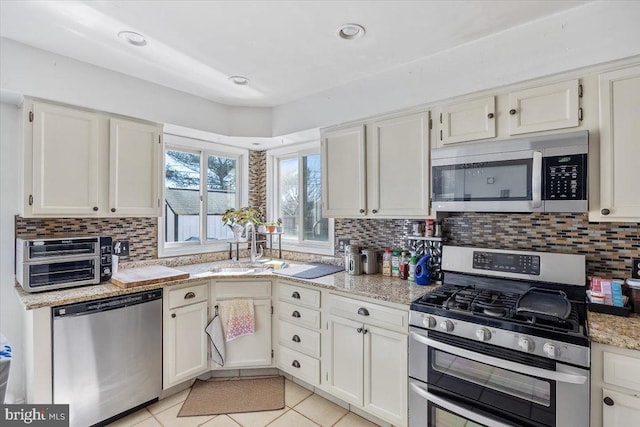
[273,1,640,135]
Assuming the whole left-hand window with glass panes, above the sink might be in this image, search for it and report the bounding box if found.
[159,135,248,256]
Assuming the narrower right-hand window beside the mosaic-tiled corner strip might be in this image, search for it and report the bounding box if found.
[267,143,333,255]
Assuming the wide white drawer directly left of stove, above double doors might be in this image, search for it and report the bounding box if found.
[329,295,409,332]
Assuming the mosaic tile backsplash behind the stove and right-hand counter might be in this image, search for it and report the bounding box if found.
[335,212,640,279]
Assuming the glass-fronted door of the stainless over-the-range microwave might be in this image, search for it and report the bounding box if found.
[431,150,544,212]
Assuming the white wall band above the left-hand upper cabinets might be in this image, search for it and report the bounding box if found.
[0,38,271,137]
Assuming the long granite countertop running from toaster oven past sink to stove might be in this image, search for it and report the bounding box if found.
[16,261,437,310]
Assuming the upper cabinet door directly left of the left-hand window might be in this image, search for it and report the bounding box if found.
[109,119,162,216]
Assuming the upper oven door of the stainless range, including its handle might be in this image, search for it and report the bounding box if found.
[409,327,589,427]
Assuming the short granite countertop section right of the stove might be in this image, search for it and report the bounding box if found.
[587,311,640,350]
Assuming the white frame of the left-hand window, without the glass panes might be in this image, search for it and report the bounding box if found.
[158,130,249,258]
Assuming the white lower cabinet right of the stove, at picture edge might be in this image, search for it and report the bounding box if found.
[591,343,640,427]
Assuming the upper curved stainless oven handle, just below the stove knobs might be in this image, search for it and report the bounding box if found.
[409,332,587,384]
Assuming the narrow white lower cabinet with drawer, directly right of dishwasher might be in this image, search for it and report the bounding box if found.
[162,284,209,388]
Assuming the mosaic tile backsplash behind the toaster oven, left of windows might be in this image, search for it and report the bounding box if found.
[16,216,158,261]
